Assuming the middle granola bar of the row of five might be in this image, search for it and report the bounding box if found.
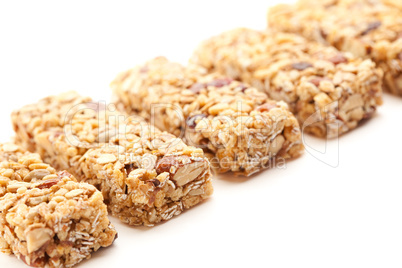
[111,57,303,175]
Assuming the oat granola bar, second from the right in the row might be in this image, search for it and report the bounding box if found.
[191,28,382,138]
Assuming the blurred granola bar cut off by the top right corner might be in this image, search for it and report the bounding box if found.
[268,0,402,95]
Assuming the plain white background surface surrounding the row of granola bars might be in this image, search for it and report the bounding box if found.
[0,0,402,268]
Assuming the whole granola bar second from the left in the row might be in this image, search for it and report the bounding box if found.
[12,92,213,226]
